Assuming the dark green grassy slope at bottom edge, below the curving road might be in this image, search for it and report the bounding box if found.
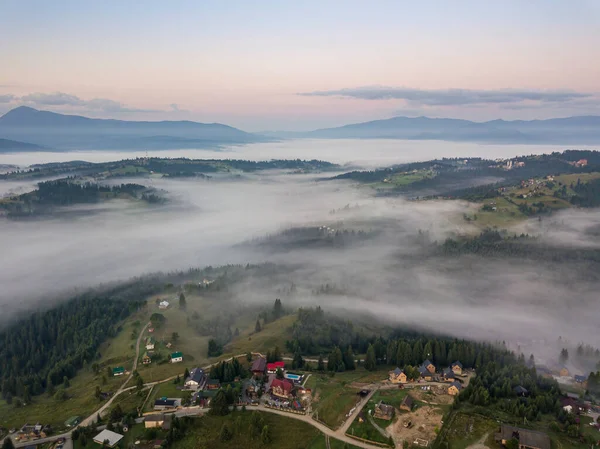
[172,411,324,449]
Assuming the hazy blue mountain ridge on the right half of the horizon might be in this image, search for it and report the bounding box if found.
[294,116,600,144]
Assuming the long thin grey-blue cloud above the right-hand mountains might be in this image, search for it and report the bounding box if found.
[298,86,595,107]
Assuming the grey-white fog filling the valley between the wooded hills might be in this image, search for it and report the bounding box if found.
[0,142,600,356]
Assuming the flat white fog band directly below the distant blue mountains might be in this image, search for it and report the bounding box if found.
[0,139,594,167]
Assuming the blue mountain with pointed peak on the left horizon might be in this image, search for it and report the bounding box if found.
[0,106,269,150]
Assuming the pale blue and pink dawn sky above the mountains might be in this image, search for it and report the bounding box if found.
[0,0,600,131]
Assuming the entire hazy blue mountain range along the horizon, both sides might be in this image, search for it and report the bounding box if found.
[0,106,600,152]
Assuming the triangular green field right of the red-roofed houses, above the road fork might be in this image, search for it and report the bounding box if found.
[306,368,387,429]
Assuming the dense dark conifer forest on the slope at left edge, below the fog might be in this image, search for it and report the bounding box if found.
[0,277,164,401]
